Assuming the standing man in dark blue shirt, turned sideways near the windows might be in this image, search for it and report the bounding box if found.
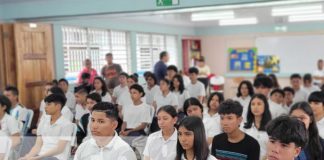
[154,51,169,83]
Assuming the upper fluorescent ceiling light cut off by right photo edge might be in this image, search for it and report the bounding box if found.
[271,4,323,16]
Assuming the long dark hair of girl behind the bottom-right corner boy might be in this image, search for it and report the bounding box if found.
[289,102,324,159]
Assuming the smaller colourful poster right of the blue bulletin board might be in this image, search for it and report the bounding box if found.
[258,55,280,74]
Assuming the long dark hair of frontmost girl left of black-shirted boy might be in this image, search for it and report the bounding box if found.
[176,116,209,160]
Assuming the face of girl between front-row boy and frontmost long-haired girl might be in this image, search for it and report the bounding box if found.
[157,111,177,131]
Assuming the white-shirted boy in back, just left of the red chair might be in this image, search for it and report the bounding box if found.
[186,67,206,103]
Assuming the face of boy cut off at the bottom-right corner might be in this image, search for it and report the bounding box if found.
[267,137,301,160]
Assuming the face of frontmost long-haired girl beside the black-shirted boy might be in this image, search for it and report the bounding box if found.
[178,126,195,150]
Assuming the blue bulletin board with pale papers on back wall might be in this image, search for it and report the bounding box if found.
[228,48,257,72]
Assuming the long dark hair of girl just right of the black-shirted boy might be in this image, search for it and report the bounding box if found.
[244,94,271,131]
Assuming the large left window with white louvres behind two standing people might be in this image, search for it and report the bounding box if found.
[62,26,131,83]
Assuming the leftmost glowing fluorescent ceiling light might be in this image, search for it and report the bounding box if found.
[191,11,234,21]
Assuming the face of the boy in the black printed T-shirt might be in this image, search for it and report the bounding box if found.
[220,113,242,134]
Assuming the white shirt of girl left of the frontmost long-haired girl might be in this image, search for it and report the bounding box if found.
[143,129,178,160]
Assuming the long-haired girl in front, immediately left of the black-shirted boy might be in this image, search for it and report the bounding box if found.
[176,116,216,160]
